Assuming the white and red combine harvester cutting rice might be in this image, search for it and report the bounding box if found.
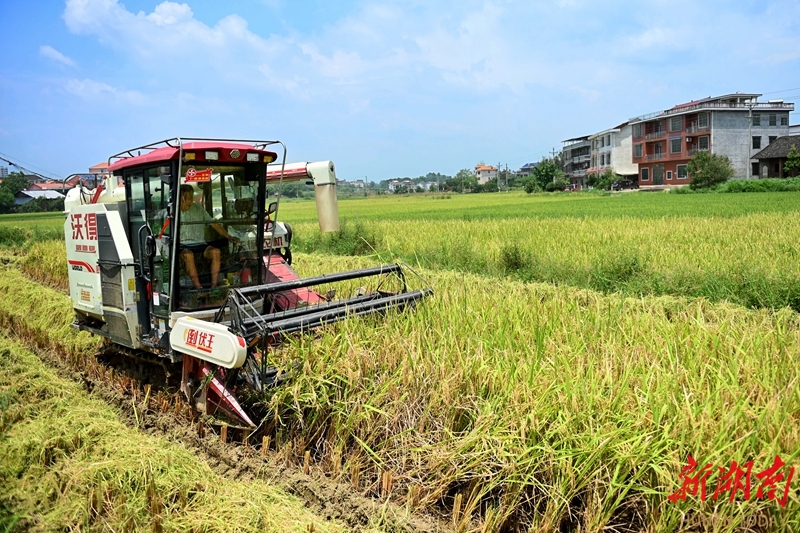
[64,138,431,427]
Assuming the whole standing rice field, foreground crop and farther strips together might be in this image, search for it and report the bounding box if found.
[0,193,800,532]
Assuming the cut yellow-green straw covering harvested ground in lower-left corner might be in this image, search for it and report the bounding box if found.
[0,336,347,532]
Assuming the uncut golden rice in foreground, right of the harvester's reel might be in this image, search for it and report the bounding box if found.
[0,244,800,531]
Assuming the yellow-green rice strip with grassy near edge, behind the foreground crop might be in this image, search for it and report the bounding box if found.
[293,210,800,310]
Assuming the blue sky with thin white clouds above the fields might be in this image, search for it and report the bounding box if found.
[0,0,800,181]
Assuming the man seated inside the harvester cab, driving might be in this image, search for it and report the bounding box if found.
[180,184,239,289]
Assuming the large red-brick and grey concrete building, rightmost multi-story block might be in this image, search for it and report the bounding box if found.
[629,93,794,186]
